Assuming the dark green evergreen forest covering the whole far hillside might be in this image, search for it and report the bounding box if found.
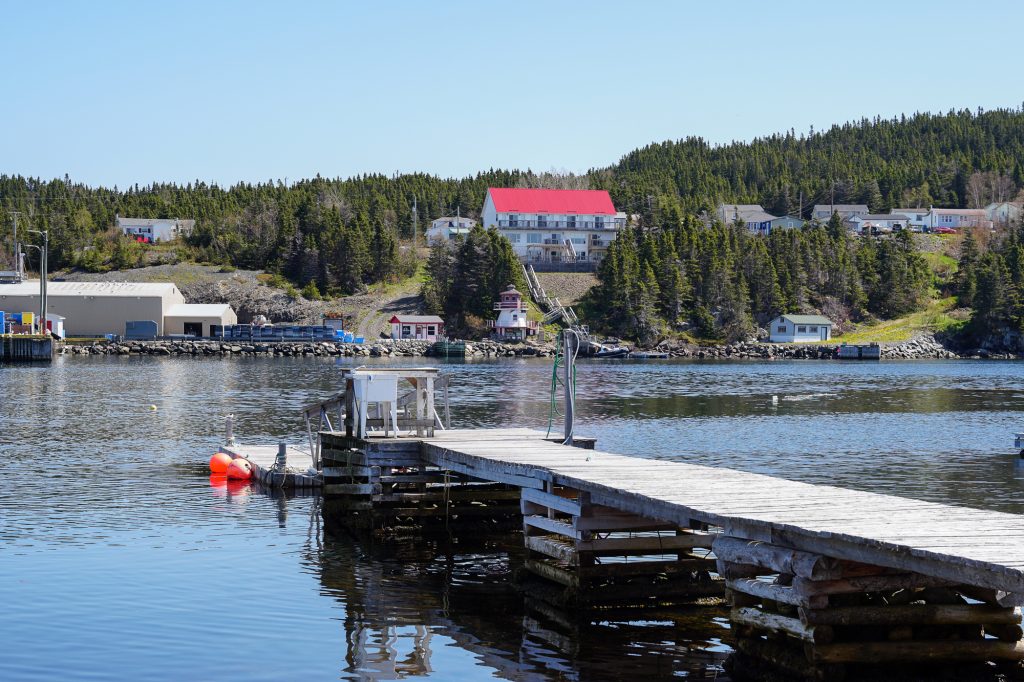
[0,110,1024,337]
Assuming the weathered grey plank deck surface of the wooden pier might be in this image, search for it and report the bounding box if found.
[413,429,1024,593]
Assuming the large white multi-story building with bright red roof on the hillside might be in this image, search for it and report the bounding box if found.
[481,187,626,264]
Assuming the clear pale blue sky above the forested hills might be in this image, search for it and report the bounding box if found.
[0,0,1024,186]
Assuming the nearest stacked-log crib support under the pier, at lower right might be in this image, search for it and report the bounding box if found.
[713,536,1024,680]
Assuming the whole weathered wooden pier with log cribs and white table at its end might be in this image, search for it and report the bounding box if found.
[232,360,1024,680]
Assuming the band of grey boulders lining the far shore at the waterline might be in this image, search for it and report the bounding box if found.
[59,329,1021,359]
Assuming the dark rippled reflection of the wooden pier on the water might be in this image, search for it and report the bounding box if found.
[307,536,730,680]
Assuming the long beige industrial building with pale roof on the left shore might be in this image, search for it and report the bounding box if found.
[0,280,238,336]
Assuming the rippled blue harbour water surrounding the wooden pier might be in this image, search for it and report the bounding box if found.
[0,357,1024,680]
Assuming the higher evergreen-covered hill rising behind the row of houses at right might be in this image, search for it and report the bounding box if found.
[592,110,1024,222]
